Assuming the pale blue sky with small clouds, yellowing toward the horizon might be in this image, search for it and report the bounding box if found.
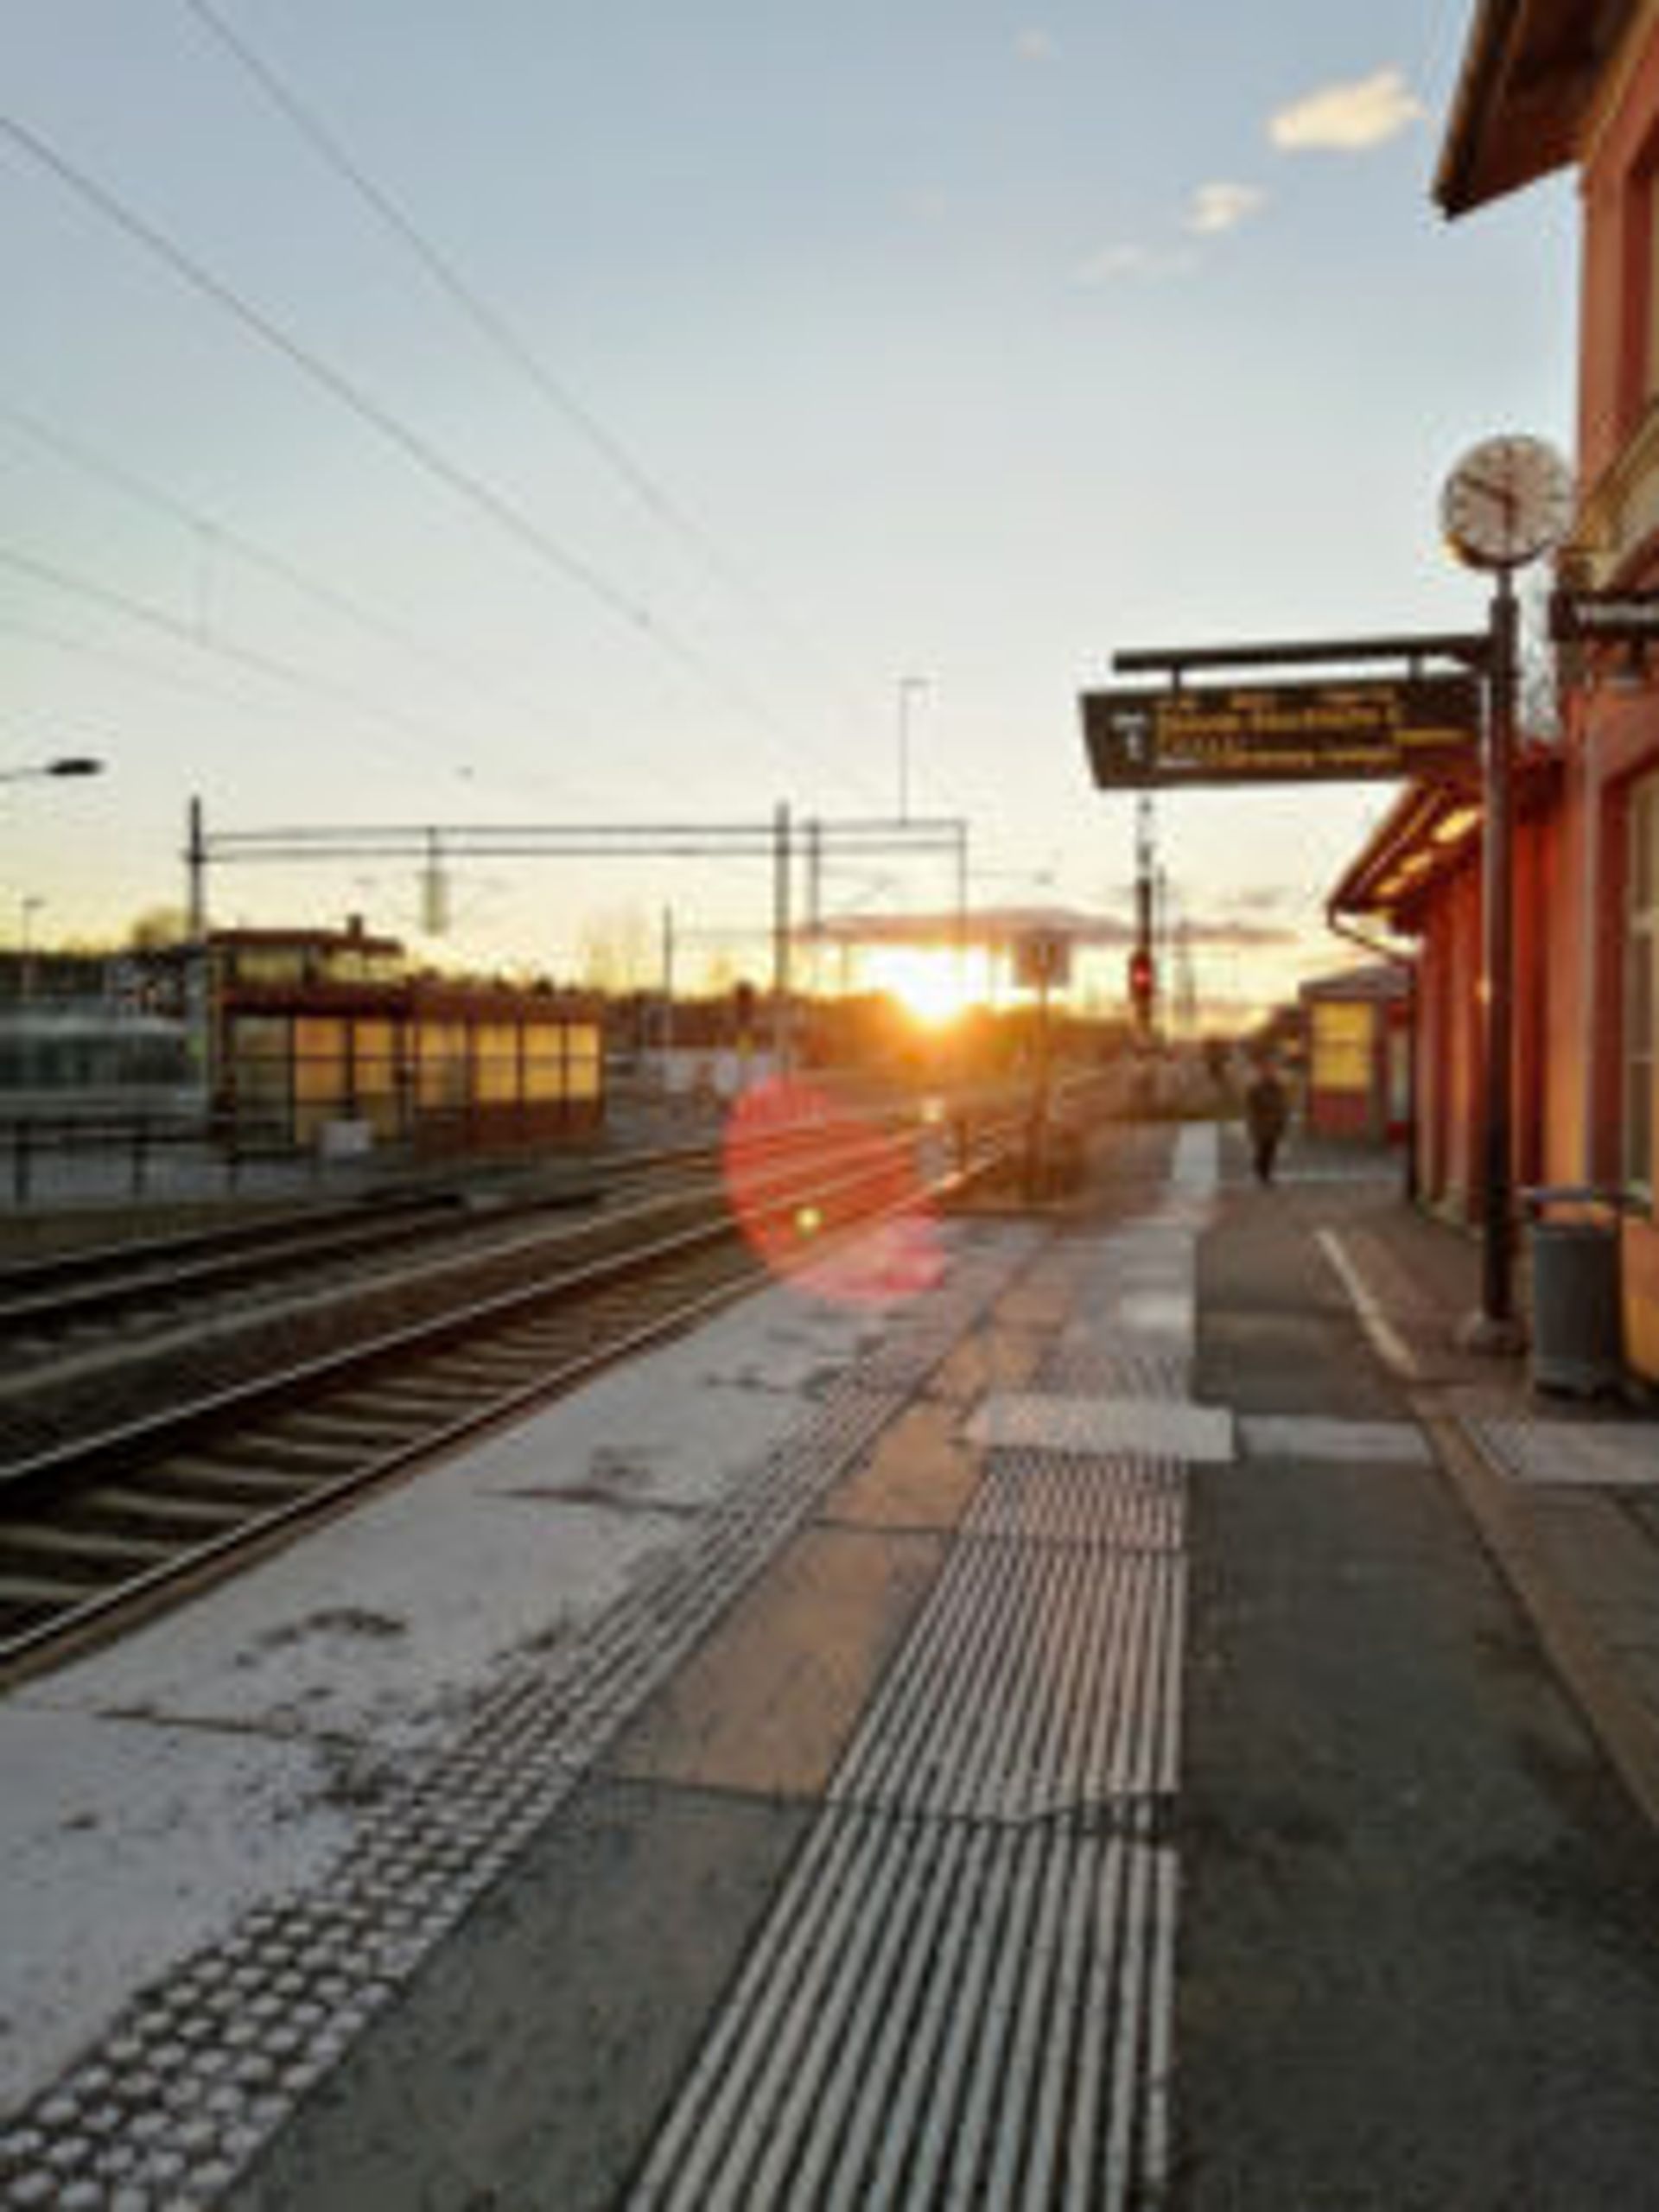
[0,0,1575,998]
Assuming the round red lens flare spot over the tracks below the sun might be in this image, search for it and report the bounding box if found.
[721,1077,944,1305]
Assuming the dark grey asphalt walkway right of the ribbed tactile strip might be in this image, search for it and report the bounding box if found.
[1173,1185,1659,2212]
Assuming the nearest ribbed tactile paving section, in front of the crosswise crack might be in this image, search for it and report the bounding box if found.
[632,1809,1174,2212]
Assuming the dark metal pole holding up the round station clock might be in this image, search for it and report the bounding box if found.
[1473,566,1520,1351]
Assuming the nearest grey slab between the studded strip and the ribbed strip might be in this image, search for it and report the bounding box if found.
[224,1781,807,2212]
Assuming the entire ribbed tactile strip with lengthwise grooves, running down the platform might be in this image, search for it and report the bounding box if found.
[631,1164,1201,2212]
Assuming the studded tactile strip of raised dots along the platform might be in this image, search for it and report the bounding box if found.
[0,1234,1035,2212]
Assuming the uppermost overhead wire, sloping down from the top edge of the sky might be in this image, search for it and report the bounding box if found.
[181,0,902,814]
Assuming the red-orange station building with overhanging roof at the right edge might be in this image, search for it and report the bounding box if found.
[1332,0,1659,1380]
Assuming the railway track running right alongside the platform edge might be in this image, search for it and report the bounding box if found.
[0,1123,1018,1679]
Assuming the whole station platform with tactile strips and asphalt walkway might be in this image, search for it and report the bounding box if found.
[0,1126,1659,2212]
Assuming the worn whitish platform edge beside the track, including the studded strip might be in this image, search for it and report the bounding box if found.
[0,1228,1028,2141]
